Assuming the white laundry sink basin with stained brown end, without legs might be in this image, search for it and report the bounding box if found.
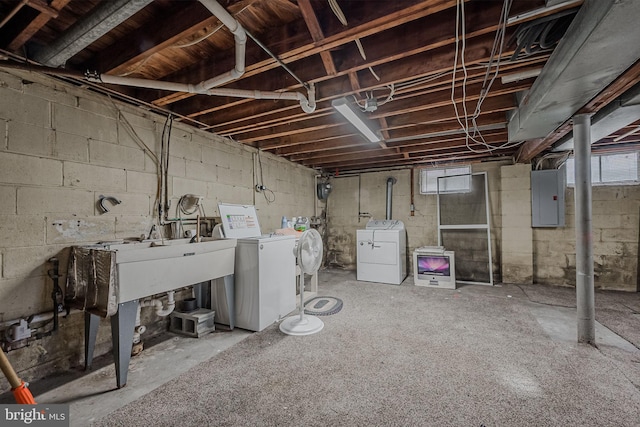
[66,239,236,316]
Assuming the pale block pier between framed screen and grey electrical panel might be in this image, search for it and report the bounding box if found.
[500,164,533,284]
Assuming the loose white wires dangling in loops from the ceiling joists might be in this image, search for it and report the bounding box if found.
[451,0,521,153]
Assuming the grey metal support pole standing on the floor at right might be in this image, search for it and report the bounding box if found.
[573,114,596,346]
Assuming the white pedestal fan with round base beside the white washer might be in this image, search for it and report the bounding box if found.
[280,228,324,335]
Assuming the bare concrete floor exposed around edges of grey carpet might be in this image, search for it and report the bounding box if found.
[1,270,640,426]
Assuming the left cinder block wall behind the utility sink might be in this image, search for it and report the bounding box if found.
[0,71,316,379]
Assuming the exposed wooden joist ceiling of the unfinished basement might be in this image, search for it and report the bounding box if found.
[0,0,640,173]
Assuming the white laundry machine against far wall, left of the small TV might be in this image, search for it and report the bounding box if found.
[356,219,407,285]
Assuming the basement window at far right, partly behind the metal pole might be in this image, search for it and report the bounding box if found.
[566,151,640,187]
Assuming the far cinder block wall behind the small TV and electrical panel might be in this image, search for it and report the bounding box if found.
[327,162,640,292]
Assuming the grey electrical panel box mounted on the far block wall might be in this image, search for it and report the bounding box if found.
[531,166,566,227]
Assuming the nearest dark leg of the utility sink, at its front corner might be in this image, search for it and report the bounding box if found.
[111,300,138,388]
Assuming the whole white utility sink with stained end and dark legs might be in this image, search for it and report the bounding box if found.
[65,239,237,388]
